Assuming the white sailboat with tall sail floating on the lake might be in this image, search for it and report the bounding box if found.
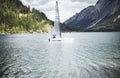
[48,1,73,41]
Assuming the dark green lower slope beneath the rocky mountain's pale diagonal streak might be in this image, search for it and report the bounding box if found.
[85,13,120,31]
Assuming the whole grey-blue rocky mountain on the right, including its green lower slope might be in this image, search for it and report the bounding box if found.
[64,0,120,31]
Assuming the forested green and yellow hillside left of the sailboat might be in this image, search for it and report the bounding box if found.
[0,0,53,33]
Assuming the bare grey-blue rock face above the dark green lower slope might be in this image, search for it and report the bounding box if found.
[64,0,120,30]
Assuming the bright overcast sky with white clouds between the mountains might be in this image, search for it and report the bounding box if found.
[21,0,97,22]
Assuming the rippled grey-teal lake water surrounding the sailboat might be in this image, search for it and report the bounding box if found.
[0,32,120,78]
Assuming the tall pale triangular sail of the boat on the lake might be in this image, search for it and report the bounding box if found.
[54,1,61,37]
